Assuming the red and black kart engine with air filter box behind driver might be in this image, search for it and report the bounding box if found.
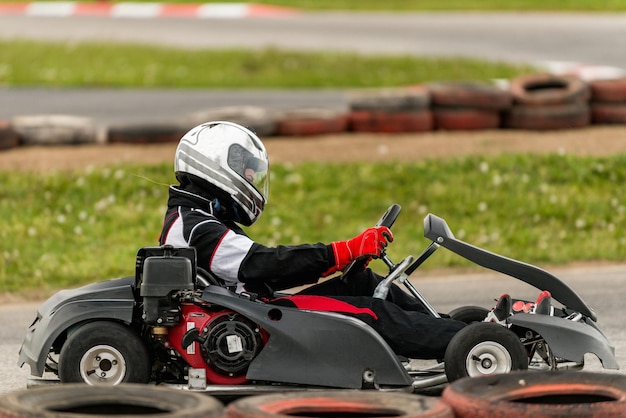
[139,247,267,385]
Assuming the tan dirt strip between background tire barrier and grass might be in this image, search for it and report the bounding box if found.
[0,126,626,172]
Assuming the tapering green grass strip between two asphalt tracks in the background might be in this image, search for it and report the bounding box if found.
[0,40,531,88]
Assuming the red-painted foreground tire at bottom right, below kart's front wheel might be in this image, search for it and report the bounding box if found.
[442,371,626,418]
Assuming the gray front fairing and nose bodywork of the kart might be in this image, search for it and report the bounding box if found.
[424,214,619,369]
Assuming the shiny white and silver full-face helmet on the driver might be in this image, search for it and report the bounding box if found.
[174,121,269,226]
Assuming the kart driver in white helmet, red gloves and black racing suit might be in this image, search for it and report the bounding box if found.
[159,122,465,359]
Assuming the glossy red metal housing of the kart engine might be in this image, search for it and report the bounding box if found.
[166,304,267,385]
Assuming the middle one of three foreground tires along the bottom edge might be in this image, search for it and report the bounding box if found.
[224,390,454,418]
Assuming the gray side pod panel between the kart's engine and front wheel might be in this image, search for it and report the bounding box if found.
[201,286,412,389]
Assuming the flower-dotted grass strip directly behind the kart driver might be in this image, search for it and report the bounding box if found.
[0,155,626,297]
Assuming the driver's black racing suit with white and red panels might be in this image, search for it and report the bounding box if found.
[159,186,465,359]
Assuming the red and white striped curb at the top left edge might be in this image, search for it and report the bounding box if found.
[0,1,297,19]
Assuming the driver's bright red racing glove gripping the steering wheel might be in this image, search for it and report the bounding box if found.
[322,226,393,277]
